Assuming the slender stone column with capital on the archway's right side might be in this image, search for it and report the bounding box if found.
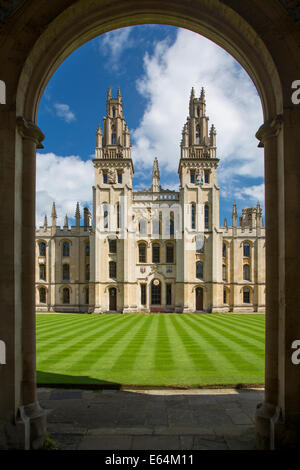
[255,116,282,449]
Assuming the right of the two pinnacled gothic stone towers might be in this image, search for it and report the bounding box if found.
[178,88,221,310]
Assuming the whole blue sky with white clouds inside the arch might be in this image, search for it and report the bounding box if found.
[37,25,264,225]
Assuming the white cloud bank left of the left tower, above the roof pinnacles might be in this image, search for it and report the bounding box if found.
[36,153,94,226]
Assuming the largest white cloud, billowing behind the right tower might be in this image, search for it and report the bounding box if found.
[132,29,264,200]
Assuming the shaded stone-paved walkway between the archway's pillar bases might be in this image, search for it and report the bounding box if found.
[38,388,263,450]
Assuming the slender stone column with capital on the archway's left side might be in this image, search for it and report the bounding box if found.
[17,117,46,448]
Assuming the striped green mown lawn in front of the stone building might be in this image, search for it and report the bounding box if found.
[37,314,265,386]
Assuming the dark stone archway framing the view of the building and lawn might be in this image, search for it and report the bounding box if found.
[0,0,300,448]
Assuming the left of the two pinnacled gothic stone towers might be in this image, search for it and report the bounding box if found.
[93,88,134,311]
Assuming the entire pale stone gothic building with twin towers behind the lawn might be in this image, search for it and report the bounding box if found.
[36,88,265,313]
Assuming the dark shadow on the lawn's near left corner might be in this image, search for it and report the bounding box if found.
[36,370,122,390]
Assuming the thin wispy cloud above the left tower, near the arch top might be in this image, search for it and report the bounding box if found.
[99,27,133,70]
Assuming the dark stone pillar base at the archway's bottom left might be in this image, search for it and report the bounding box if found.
[0,402,47,450]
